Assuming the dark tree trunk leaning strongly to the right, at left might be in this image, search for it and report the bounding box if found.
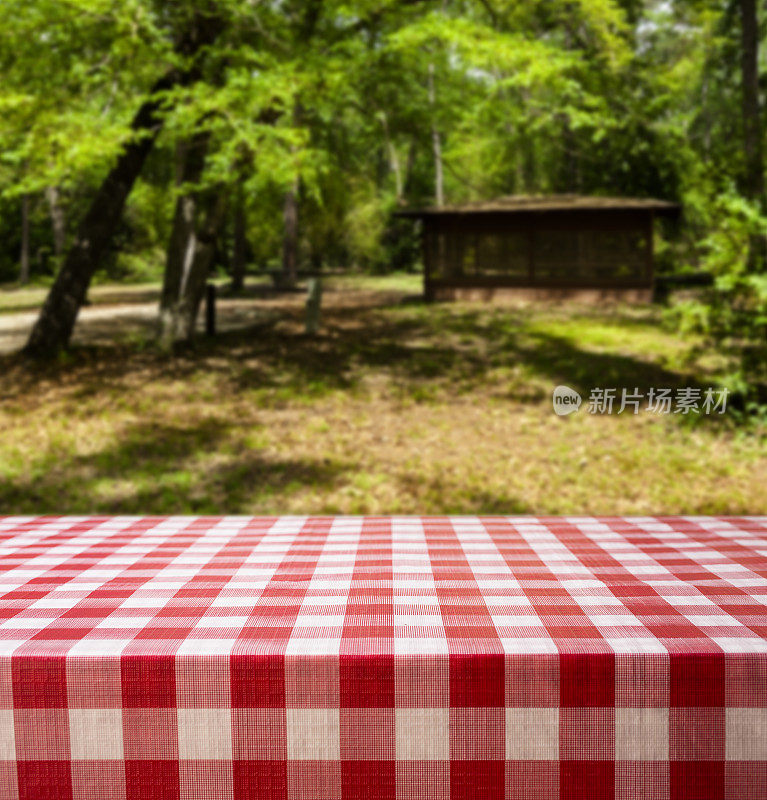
[24,14,221,357]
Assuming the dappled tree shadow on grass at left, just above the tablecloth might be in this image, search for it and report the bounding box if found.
[0,420,347,514]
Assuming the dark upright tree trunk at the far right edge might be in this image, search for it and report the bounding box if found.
[740,0,767,271]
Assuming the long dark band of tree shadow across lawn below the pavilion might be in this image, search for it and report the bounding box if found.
[0,296,728,418]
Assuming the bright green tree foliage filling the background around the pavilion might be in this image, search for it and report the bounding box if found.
[0,0,766,400]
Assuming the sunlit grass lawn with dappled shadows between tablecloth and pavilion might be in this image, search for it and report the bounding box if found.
[0,276,767,514]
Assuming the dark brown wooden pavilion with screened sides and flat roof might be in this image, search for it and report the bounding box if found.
[399,195,679,302]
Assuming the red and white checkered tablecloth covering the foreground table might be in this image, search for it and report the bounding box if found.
[0,517,767,800]
